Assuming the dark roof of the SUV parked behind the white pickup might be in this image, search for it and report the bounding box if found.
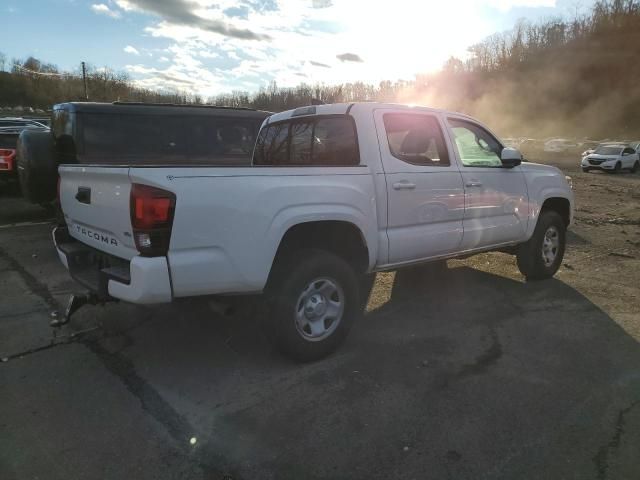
[53,102,270,118]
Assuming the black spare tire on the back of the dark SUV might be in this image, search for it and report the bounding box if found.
[16,130,58,204]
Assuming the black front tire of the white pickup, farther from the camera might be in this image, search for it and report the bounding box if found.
[516,210,567,280]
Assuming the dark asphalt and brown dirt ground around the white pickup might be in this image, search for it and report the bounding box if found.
[0,159,640,480]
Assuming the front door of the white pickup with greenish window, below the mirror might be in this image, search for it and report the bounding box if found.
[448,117,529,250]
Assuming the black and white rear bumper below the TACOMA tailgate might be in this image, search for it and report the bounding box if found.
[53,227,172,304]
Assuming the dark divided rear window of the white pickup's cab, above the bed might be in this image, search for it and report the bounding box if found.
[253,116,360,166]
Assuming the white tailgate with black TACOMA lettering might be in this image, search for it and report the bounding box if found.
[59,166,138,260]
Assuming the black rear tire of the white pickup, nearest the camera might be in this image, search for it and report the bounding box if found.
[267,249,362,362]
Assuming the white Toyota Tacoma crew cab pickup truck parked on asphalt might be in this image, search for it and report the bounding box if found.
[53,103,573,360]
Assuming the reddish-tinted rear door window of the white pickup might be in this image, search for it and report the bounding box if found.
[383,113,450,166]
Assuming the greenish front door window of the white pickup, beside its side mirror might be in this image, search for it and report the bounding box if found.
[449,118,502,167]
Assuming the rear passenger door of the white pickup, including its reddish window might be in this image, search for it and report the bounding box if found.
[374,109,464,264]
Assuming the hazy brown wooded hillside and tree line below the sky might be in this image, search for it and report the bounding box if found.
[0,0,640,138]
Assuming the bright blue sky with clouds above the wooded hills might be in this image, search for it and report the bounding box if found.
[0,0,593,96]
